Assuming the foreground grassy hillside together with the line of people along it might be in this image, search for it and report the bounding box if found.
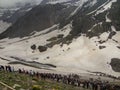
[0,67,120,90]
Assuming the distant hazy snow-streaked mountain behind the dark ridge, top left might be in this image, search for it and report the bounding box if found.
[0,3,36,33]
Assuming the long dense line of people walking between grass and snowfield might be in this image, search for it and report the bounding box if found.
[0,65,120,90]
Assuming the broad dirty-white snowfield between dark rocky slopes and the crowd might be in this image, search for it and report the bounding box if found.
[0,25,120,76]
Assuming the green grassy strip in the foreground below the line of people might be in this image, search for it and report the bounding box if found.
[0,71,87,90]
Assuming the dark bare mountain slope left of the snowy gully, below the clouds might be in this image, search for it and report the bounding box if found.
[1,4,76,37]
